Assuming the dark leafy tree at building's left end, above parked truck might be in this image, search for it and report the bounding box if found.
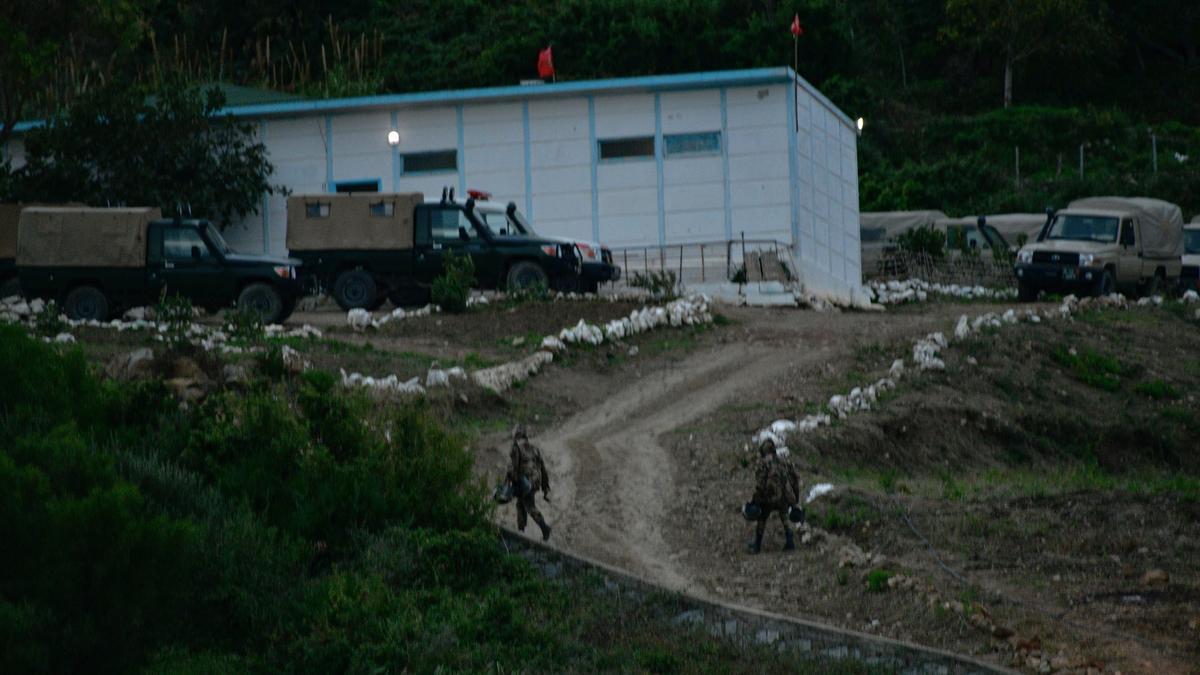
[10,85,281,227]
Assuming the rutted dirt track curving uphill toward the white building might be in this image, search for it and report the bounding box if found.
[516,305,984,596]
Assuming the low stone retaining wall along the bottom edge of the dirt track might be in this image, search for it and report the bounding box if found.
[500,526,1015,675]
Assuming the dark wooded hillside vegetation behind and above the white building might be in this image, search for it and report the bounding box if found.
[0,0,1200,214]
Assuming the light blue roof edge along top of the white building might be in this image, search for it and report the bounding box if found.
[4,66,857,133]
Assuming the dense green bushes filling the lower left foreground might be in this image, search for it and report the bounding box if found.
[0,325,852,673]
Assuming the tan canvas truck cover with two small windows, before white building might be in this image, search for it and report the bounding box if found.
[288,192,425,251]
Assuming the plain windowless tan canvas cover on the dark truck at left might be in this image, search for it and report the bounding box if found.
[17,207,162,267]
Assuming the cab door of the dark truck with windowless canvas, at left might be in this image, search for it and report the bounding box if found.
[150,225,230,305]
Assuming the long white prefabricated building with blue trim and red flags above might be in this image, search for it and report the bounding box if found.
[6,67,862,299]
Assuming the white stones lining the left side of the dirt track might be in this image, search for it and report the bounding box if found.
[341,295,713,396]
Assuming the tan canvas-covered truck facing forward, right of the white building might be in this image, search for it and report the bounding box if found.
[1014,197,1183,300]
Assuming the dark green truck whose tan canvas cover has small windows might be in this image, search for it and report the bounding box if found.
[287,192,581,310]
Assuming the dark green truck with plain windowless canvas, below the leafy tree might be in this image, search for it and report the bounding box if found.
[17,207,301,323]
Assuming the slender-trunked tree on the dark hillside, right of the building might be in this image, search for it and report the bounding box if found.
[942,0,1109,108]
